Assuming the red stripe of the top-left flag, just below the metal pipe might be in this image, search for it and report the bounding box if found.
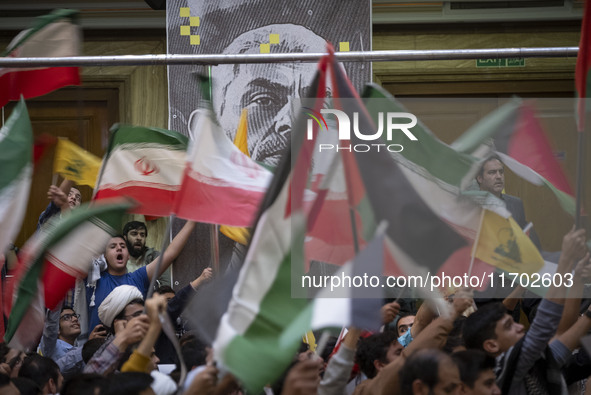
[0,67,80,107]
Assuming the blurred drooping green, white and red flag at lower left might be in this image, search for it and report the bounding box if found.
[4,199,132,350]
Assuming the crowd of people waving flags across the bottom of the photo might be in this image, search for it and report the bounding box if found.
[0,157,591,395]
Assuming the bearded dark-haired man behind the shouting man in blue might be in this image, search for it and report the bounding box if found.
[123,221,171,286]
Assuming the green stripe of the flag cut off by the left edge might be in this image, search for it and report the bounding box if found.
[0,99,33,189]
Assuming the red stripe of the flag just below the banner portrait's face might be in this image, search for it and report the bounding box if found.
[175,175,265,226]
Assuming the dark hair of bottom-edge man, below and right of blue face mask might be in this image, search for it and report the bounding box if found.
[399,349,449,394]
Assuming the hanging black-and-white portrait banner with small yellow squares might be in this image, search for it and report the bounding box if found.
[166,0,372,286]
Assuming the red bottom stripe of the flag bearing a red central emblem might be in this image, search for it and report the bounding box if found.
[94,186,178,217]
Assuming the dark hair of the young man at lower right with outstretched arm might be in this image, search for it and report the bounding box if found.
[462,302,507,351]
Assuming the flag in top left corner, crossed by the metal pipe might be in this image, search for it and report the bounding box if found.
[0,10,82,107]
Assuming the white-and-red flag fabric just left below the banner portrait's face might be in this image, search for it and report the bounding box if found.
[173,109,272,226]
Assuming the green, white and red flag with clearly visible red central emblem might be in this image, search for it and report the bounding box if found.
[94,125,188,217]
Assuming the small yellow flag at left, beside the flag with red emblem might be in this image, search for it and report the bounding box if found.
[53,137,101,188]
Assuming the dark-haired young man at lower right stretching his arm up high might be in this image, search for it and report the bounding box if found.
[463,229,588,394]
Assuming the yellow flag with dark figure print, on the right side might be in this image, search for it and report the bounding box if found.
[475,210,544,274]
